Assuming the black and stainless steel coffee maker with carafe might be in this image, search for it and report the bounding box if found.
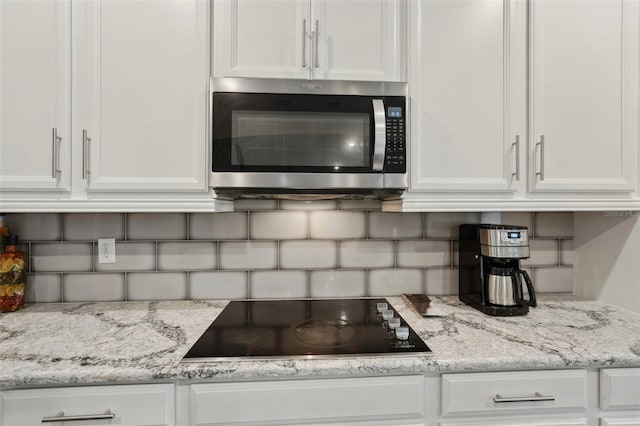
[458,224,536,316]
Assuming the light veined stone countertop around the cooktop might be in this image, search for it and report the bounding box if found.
[0,294,640,388]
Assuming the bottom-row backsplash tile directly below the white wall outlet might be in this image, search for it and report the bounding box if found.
[63,273,125,302]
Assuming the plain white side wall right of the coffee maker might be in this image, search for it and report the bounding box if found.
[574,212,640,312]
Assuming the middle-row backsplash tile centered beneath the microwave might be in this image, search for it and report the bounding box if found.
[280,241,338,269]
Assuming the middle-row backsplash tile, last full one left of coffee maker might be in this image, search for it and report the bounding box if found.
[397,240,451,268]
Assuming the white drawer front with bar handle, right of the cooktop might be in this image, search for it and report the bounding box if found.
[442,370,587,416]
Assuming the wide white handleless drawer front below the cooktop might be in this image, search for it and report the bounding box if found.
[190,376,424,425]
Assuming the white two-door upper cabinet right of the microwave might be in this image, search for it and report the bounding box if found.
[402,0,640,211]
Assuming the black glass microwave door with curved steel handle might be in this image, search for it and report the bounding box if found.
[213,93,384,173]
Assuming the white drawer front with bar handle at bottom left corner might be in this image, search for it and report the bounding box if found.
[2,384,174,426]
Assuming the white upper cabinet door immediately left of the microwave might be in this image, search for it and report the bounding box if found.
[74,0,209,192]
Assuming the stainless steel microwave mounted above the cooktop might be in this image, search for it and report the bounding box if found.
[210,79,407,198]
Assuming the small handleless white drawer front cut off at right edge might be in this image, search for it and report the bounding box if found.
[600,368,640,409]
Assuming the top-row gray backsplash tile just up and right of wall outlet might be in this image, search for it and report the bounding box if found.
[127,213,187,240]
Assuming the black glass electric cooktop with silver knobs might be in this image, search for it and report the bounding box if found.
[184,299,431,361]
